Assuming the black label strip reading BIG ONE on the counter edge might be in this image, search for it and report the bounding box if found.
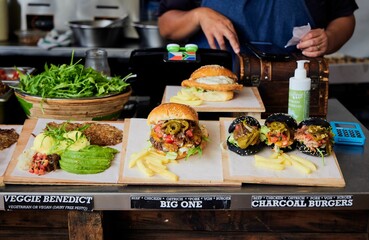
[131,196,231,209]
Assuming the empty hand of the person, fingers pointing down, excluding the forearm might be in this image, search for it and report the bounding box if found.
[198,7,240,53]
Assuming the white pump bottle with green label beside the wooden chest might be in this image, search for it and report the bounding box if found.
[288,60,311,122]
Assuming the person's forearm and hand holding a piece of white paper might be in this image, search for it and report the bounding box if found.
[297,15,355,57]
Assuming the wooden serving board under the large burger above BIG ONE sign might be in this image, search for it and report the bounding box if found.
[119,118,241,186]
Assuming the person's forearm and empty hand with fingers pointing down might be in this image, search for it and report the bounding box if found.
[158,7,240,53]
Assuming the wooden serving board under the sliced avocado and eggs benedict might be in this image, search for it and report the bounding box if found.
[4,119,124,185]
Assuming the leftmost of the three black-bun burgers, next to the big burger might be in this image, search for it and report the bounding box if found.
[227,116,263,156]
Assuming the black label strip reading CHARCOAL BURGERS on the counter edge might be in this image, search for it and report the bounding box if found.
[251,195,354,208]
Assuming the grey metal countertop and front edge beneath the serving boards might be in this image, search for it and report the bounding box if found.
[0,99,369,210]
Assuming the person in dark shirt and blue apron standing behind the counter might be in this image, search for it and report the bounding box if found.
[158,0,358,57]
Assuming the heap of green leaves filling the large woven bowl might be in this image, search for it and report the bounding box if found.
[14,51,132,98]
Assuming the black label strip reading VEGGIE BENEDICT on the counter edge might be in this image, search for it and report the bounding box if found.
[4,194,94,211]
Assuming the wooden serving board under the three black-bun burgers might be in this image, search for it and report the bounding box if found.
[220,118,346,187]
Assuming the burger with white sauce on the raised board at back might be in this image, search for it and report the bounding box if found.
[181,64,243,102]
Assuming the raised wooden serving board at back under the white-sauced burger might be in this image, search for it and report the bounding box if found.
[162,86,265,113]
